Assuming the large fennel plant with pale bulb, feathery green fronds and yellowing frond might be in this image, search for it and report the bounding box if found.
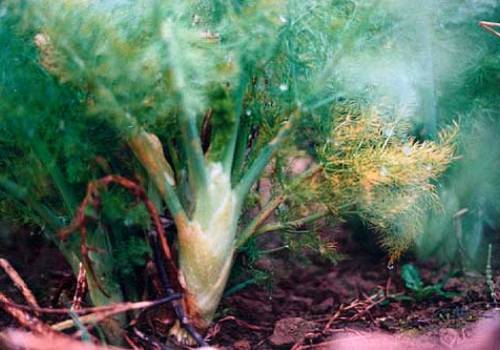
[0,0,454,341]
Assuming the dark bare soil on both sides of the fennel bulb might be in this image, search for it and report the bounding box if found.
[0,224,500,350]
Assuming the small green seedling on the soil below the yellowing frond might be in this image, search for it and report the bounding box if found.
[401,264,456,301]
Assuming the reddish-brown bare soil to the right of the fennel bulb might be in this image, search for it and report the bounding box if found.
[211,242,500,350]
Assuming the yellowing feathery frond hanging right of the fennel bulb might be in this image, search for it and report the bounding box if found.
[284,103,458,259]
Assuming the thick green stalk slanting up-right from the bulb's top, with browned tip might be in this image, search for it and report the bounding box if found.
[236,109,301,202]
